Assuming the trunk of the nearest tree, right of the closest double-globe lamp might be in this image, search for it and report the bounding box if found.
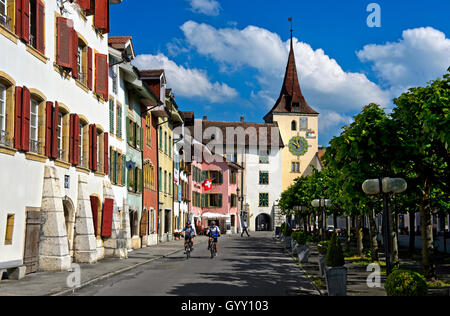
[419,202,436,280]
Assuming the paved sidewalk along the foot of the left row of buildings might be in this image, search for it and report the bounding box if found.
[0,236,207,296]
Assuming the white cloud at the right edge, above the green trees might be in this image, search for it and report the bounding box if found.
[357,27,450,94]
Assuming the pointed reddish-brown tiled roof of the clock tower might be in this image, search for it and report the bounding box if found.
[265,36,319,118]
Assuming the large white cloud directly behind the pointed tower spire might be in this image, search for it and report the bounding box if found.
[181,21,390,116]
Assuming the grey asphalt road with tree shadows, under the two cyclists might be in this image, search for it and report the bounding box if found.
[74,233,319,296]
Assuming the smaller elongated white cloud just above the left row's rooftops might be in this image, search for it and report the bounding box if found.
[134,54,238,103]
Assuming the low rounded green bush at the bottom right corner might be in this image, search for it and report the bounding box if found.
[385,270,428,296]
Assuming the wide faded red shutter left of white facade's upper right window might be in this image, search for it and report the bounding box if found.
[56,17,73,69]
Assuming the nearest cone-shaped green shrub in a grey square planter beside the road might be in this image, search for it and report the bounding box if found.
[325,232,347,296]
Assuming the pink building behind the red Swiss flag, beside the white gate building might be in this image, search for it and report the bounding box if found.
[190,156,242,234]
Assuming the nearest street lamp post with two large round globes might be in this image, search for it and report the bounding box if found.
[362,178,408,275]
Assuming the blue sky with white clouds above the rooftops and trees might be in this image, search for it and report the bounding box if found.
[110,0,450,146]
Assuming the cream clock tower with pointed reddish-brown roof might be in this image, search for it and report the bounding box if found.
[264,30,319,191]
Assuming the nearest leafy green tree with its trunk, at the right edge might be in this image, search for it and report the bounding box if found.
[392,68,450,279]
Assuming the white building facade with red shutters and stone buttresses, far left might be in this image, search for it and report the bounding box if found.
[0,0,126,272]
